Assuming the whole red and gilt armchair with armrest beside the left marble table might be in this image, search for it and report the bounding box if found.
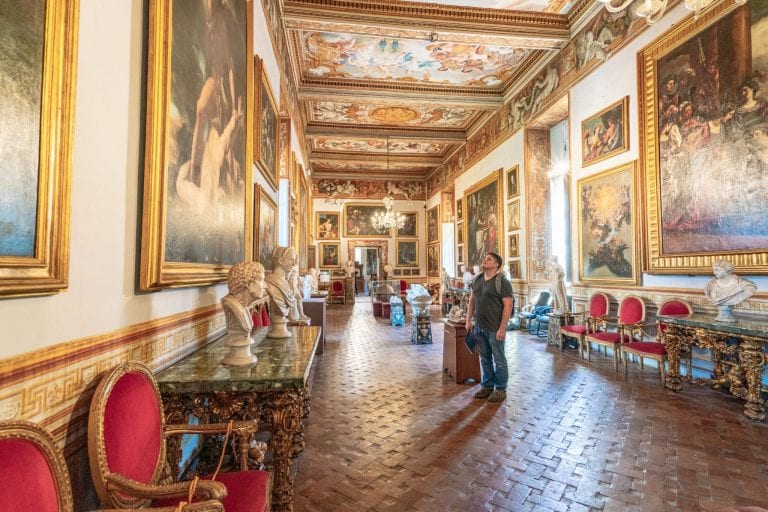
[88,362,272,512]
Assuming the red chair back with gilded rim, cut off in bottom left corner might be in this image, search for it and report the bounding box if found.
[0,421,73,512]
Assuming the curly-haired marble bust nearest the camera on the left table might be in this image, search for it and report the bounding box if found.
[221,261,266,365]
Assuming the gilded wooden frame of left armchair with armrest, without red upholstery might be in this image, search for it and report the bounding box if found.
[88,362,264,512]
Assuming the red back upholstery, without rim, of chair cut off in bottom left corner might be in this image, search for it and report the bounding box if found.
[0,439,59,512]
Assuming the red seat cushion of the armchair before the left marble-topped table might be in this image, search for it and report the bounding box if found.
[152,470,269,512]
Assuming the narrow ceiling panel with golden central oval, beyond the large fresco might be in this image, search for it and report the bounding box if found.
[310,101,477,129]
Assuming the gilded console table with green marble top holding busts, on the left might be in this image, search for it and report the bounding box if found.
[157,326,320,511]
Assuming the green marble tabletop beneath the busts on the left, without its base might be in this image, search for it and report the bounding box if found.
[156,327,320,393]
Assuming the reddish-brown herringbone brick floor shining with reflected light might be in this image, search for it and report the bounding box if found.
[294,302,768,512]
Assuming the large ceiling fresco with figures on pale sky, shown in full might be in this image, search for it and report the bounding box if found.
[299,31,530,90]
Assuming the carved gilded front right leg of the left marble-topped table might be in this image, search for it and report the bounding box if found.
[272,390,303,512]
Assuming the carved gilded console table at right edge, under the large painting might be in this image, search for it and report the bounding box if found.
[658,313,768,420]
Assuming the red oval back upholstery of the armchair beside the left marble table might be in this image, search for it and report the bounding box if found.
[104,372,162,483]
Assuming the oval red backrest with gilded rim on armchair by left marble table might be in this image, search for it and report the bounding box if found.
[88,363,165,507]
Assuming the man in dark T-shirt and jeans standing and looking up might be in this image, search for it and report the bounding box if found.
[466,252,513,402]
